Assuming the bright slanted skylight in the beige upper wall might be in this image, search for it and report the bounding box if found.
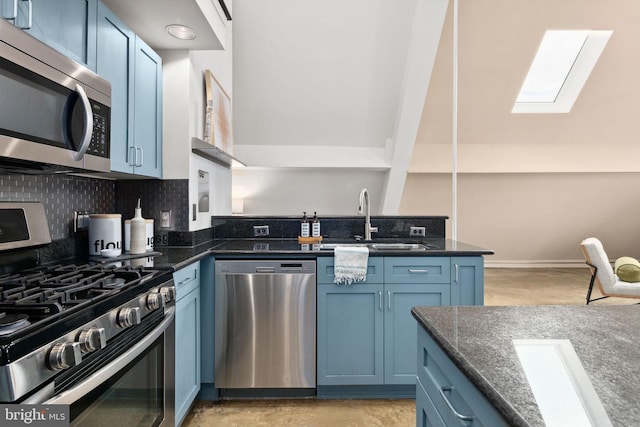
[511,30,612,113]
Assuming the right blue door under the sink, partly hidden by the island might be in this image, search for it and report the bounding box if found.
[384,284,451,384]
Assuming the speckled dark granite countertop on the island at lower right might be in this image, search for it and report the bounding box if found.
[412,305,640,426]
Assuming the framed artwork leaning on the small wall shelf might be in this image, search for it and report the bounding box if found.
[203,70,233,154]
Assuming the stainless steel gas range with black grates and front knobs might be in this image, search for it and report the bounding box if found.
[0,203,175,426]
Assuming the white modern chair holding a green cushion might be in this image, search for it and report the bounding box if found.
[580,237,640,305]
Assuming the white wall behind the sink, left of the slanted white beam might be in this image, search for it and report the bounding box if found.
[233,0,417,215]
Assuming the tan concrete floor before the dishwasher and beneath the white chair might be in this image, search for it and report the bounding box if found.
[183,267,638,427]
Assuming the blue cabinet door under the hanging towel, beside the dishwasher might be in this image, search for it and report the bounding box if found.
[317,283,382,385]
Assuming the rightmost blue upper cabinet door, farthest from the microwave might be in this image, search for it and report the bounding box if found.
[133,37,162,178]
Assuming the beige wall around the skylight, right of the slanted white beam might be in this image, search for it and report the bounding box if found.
[400,0,640,266]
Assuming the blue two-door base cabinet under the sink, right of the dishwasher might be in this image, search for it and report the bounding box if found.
[317,257,451,386]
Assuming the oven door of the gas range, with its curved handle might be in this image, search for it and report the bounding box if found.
[44,307,175,427]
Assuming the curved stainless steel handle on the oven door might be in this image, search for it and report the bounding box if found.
[44,306,175,405]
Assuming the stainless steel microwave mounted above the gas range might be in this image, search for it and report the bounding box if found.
[0,19,111,173]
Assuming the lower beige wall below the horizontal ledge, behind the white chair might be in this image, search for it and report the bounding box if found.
[401,173,640,266]
